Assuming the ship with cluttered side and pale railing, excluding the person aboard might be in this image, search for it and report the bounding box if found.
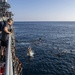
[0,0,23,75]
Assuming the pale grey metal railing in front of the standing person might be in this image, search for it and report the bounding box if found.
[4,34,14,75]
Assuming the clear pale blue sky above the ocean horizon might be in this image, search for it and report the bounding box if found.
[8,0,75,21]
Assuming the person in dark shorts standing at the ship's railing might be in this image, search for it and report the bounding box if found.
[1,18,13,60]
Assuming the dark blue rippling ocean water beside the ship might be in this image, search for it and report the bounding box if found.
[14,22,75,75]
